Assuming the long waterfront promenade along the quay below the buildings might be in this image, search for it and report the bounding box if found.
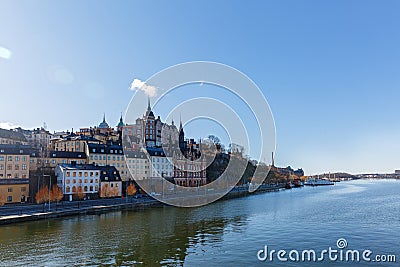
[0,184,284,225]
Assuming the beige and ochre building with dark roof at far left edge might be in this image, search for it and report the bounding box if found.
[0,144,31,203]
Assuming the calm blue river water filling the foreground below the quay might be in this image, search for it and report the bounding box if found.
[0,180,400,266]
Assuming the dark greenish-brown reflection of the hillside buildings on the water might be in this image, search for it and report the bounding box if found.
[0,202,250,266]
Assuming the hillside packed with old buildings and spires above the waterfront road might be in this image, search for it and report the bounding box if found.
[0,100,304,203]
